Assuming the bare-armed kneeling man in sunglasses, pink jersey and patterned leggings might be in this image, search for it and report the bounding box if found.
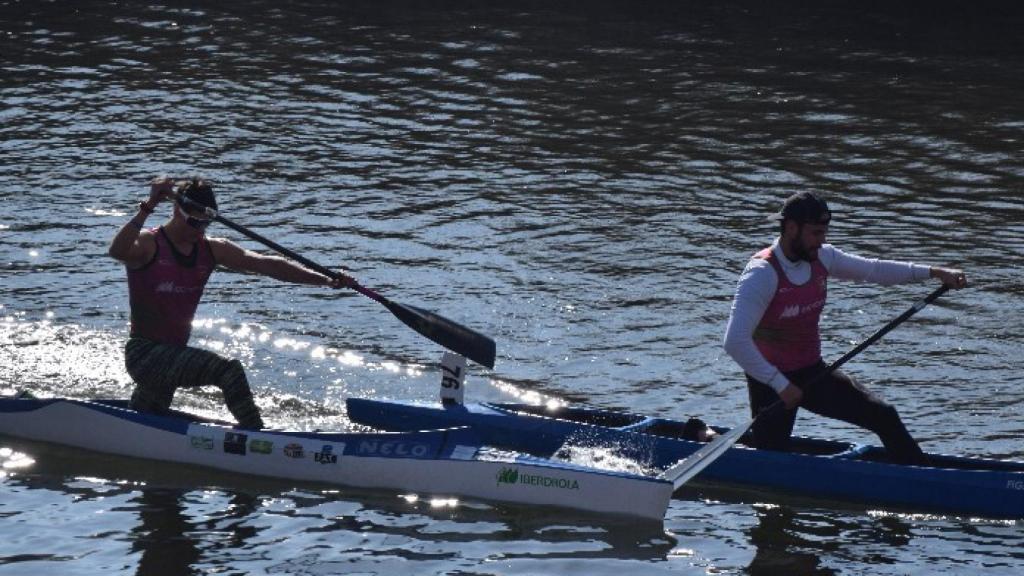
[109,178,351,428]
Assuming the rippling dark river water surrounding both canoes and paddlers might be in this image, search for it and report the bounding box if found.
[0,0,1024,576]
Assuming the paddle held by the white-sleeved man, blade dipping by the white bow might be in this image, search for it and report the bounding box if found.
[662,284,949,490]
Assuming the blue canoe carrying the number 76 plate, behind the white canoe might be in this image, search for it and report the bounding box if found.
[347,399,1024,519]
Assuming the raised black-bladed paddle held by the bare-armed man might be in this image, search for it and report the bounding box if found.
[170,192,496,369]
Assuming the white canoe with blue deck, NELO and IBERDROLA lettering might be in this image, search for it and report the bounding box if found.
[0,397,673,522]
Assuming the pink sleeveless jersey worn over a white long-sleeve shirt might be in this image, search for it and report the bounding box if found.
[754,248,828,372]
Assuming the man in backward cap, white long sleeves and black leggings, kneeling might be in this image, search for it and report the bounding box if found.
[725,192,967,463]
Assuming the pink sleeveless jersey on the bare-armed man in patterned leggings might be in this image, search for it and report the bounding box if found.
[128,228,216,346]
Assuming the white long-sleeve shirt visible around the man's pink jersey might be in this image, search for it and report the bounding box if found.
[724,240,931,393]
